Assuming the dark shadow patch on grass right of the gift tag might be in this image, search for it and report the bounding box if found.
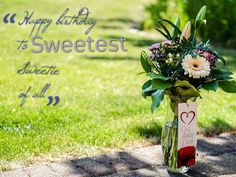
[203,118,233,136]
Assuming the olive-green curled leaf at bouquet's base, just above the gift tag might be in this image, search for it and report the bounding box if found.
[175,81,200,99]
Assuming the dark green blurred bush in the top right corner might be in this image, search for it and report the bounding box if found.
[184,0,236,48]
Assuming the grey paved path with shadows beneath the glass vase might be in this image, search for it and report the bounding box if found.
[0,134,236,177]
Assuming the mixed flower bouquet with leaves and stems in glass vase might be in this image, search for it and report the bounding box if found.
[140,6,236,173]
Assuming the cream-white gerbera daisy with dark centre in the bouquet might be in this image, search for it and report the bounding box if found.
[182,54,211,78]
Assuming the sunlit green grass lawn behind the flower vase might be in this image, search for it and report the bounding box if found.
[0,0,236,169]
